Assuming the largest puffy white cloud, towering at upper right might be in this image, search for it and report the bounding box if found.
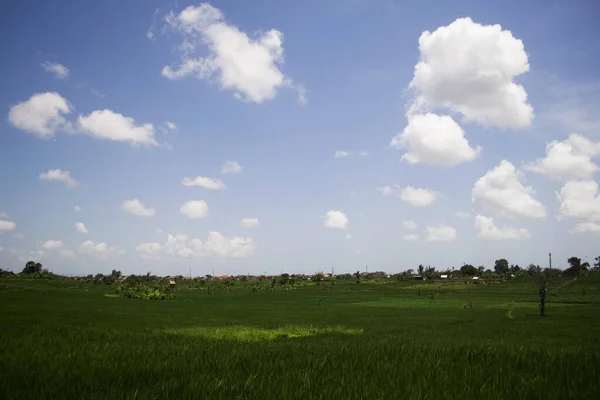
[410,18,534,128]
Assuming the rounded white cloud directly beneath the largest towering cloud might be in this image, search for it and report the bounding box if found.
[391,113,481,167]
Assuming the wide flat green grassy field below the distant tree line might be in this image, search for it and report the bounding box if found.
[0,276,600,399]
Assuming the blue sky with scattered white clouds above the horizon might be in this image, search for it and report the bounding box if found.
[0,0,600,276]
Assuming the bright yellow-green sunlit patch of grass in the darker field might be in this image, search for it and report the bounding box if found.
[166,325,363,342]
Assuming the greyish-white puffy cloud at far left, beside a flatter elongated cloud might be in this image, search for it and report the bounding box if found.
[8,92,71,138]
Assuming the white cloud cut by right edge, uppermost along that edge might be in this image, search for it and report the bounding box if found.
[523,134,600,181]
